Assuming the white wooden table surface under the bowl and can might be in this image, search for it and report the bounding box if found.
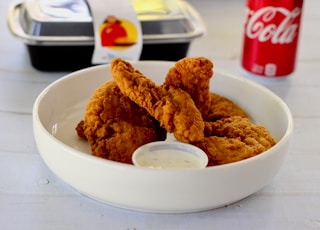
[0,0,320,230]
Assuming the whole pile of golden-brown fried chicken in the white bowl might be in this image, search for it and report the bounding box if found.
[76,57,275,166]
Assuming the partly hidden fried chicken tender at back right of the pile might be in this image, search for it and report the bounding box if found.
[206,93,248,121]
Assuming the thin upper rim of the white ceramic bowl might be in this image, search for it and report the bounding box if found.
[32,60,293,173]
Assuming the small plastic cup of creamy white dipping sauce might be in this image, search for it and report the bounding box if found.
[132,141,208,169]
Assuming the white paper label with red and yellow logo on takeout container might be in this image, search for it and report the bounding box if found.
[88,0,143,64]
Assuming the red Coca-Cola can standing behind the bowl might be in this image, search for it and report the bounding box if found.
[242,0,303,77]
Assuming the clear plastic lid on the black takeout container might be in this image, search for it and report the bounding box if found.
[9,0,205,45]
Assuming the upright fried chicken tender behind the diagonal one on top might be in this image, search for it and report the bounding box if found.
[163,57,213,120]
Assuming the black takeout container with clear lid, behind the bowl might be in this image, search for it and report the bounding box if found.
[7,0,205,71]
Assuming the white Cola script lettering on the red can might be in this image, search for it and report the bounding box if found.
[245,6,301,44]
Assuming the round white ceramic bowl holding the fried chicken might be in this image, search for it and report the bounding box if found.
[33,61,293,213]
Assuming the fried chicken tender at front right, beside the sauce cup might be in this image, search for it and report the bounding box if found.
[193,116,275,166]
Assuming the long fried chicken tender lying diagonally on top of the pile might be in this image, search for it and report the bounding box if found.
[111,58,204,143]
